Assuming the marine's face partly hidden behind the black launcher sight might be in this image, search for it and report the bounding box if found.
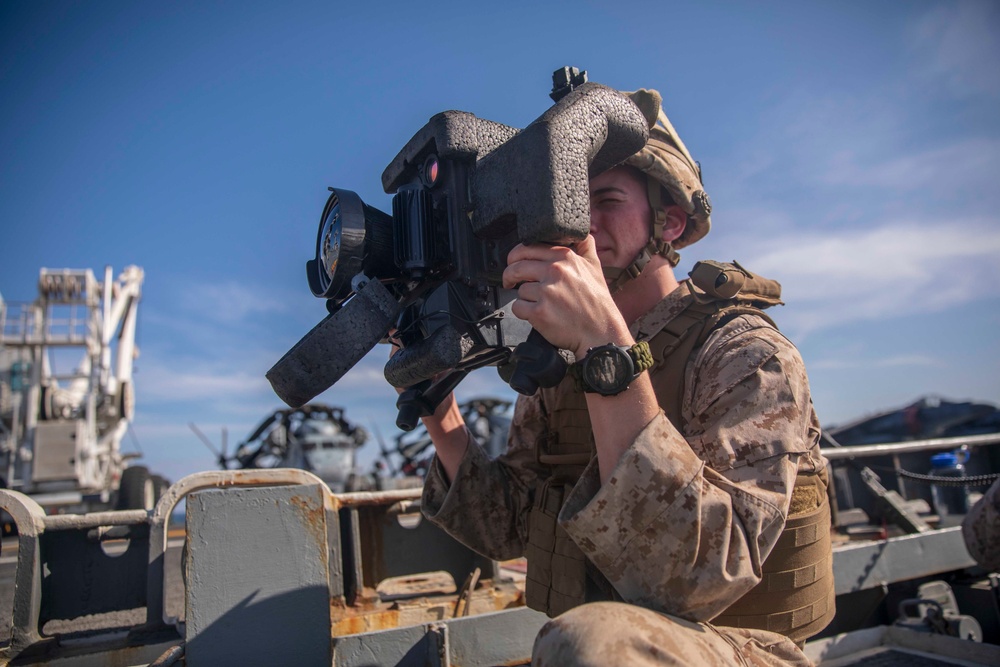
[590,167,653,268]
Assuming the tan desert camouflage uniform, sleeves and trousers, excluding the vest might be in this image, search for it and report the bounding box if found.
[423,286,824,664]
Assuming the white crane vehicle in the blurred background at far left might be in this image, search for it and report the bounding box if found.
[0,266,166,511]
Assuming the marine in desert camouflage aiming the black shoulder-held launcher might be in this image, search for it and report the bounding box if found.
[402,91,832,665]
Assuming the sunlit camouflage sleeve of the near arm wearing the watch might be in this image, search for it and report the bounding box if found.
[560,322,819,621]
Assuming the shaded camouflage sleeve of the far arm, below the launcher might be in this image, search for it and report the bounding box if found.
[421,394,545,560]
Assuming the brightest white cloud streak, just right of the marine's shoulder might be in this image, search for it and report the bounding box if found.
[743,219,1000,336]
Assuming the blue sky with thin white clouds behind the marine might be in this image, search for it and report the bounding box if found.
[0,0,1000,480]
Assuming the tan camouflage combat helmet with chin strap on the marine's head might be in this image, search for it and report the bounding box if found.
[605,88,712,289]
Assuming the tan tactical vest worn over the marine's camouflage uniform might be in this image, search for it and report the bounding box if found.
[525,262,835,642]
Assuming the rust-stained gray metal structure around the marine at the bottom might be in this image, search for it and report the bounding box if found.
[0,436,1000,667]
